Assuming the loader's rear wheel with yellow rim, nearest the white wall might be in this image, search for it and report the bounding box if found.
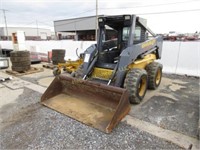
[146,62,163,90]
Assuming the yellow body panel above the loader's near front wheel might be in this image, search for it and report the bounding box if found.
[128,54,156,69]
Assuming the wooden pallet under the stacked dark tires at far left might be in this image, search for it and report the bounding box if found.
[6,67,44,76]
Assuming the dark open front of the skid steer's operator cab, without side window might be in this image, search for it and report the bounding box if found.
[97,15,132,69]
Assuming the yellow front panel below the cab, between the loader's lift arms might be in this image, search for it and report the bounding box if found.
[92,67,113,79]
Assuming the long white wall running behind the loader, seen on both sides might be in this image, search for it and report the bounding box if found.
[0,40,200,77]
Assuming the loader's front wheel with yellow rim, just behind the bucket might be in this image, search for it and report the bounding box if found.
[124,69,147,104]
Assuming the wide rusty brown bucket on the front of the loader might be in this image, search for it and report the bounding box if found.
[41,75,130,133]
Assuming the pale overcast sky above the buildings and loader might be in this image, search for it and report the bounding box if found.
[0,0,200,33]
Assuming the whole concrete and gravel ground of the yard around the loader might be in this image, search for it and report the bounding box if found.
[0,64,200,149]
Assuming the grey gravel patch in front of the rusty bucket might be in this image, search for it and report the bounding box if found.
[0,103,180,150]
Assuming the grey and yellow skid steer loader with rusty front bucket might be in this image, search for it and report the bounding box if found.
[41,15,162,133]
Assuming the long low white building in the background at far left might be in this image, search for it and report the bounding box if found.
[0,27,51,40]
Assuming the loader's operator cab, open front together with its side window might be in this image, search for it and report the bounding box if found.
[96,15,146,69]
